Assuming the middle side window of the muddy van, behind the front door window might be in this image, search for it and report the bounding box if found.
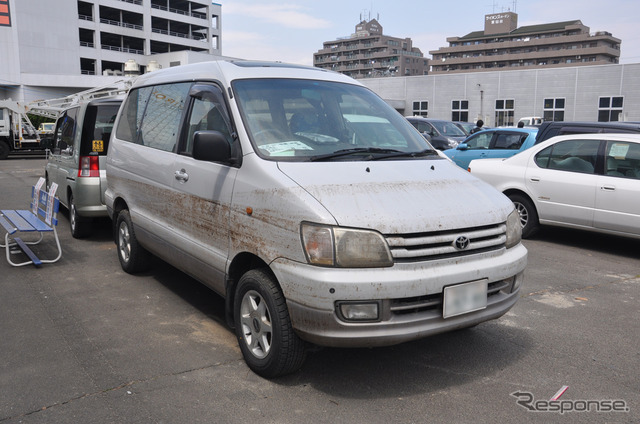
[138,82,191,152]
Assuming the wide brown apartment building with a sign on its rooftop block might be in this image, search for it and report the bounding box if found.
[429,12,621,74]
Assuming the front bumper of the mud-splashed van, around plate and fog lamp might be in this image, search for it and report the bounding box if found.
[272,244,527,347]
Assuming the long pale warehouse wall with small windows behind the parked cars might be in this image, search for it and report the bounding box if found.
[359,63,640,125]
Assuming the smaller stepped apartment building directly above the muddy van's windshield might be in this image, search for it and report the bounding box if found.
[313,19,429,78]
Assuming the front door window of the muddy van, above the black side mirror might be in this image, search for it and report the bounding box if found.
[180,84,233,155]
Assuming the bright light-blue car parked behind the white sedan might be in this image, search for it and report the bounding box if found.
[444,128,538,169]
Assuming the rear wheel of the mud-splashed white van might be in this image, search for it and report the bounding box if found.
[116,209,150,274]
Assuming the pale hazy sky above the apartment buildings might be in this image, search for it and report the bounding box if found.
[219,0,640,65]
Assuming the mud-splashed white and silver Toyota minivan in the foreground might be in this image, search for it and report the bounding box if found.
[105,61,527,377]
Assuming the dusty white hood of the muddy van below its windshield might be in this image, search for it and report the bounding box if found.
[278,160,513,234]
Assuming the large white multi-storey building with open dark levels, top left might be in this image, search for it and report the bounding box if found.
[0,0,222,100]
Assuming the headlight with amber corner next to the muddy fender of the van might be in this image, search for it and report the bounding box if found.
[300,223,393,268]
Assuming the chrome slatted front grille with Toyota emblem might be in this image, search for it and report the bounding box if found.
[385,223,507,262]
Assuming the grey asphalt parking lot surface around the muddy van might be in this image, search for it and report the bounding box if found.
[0,157,640,424]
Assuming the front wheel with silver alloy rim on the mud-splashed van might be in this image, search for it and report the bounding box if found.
[233,269,306,378]
